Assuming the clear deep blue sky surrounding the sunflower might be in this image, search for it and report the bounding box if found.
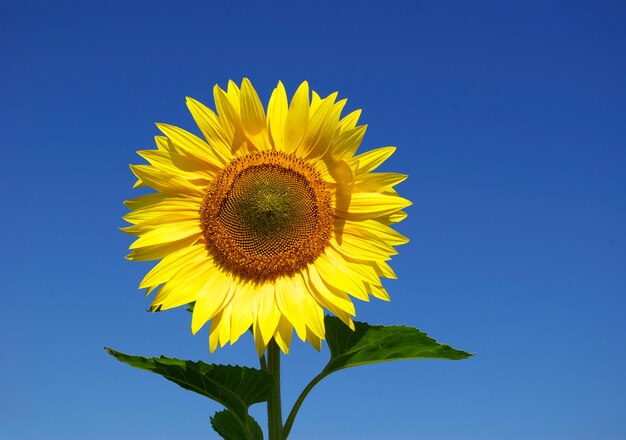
[0,0,626,440]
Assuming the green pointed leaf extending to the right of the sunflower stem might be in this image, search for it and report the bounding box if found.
[324,316,472,374]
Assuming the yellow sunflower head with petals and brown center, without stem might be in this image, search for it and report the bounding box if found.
[122,79,411,355]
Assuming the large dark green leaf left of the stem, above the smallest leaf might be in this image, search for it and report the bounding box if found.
[105,348,275,423]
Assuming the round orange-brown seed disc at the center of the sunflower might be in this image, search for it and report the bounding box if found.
[200,151,334,280]
